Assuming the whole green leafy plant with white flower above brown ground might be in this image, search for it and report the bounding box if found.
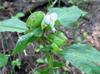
[0,6,100,74]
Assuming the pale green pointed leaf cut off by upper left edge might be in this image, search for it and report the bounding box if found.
[0,17,28,33]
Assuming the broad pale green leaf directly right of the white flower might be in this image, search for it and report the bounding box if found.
[49,6,87,26]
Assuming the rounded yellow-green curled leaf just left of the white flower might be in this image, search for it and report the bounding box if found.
[26,11,45,29]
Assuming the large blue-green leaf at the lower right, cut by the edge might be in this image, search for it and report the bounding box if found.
[64,44,100,74]
